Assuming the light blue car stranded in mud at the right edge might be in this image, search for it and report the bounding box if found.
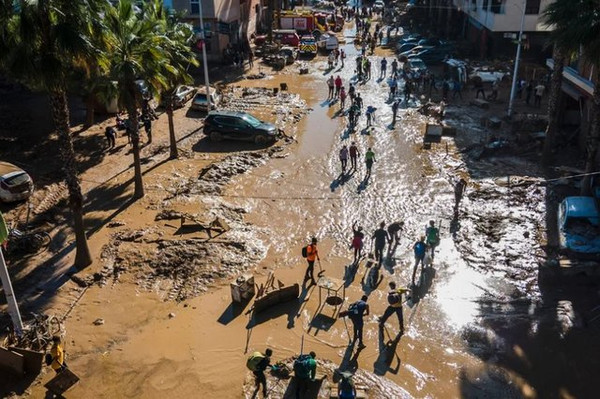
[558,197,600,257]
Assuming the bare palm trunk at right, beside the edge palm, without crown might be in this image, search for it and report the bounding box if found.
[542,46,566,166]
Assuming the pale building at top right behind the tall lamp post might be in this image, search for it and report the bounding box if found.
[452,0,552,60]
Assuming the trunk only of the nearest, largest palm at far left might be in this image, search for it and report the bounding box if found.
[50,90,92,269]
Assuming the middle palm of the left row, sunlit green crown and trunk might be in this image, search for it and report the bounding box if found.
[105,0,167,199]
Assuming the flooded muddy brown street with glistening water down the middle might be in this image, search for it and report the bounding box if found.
[4,14,600,398]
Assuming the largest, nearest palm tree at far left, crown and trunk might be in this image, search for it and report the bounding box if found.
[0,0,94,268]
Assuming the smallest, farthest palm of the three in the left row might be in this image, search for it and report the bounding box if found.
[163,10,199,159]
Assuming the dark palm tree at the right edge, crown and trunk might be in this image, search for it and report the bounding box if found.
[544,0,600,195]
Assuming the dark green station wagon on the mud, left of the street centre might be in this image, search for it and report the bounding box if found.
[204,111,279,144]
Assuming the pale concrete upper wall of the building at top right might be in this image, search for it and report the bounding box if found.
[453,0,552,32]
